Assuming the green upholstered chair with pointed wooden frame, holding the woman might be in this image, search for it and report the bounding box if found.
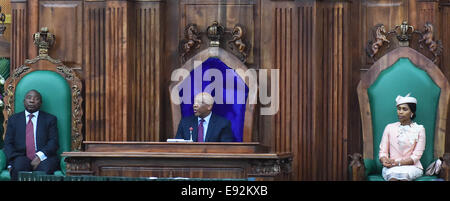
[350,47,449,181]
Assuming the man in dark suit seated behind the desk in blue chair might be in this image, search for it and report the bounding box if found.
[175,93,234,142]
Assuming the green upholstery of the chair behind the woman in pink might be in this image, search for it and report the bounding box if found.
[366,58,440,180]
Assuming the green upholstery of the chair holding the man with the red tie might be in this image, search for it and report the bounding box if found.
[0,71,72,180]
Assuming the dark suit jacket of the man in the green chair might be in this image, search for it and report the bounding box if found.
[3,111,59,162]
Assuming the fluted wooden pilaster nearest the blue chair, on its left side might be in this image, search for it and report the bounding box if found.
[128,3,164,141]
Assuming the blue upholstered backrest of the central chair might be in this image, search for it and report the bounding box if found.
[179,57,249,142]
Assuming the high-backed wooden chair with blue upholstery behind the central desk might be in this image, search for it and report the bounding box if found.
[169,47,257,142]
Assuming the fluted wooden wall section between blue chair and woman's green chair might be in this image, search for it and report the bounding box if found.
[262,1,350,180]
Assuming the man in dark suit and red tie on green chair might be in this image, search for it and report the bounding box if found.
[4,90,59,181]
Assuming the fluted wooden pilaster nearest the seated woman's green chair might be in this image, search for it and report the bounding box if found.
[316,3,349,180]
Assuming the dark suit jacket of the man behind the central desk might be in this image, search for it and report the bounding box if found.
[175,114,234,142]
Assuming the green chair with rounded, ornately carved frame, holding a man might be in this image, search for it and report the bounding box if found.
[0,56,82,180]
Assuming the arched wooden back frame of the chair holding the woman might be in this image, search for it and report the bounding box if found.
[357,47,450,159]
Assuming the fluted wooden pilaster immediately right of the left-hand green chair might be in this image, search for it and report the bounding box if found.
[84,2,107,141]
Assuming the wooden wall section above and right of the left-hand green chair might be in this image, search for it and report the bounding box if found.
[11,0,164,141]
